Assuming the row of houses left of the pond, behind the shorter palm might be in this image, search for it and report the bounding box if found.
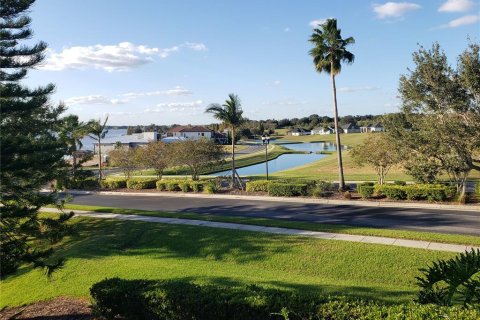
[94,126,228,153]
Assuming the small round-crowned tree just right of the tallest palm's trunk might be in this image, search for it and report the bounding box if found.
[351,133,402,184]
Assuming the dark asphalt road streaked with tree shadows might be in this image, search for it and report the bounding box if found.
[68,194,480,236]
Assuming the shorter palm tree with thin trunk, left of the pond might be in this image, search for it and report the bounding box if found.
[205,93,244,187]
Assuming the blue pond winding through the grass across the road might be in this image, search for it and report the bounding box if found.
[212,142,335,176]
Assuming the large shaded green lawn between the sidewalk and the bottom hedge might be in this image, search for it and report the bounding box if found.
[0,218,454,308]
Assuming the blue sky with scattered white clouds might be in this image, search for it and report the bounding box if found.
[26,0,480,125]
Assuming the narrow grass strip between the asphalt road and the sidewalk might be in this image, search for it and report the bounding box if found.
[60,204,480,246]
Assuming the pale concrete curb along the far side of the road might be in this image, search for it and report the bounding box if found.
[57,190,480,215]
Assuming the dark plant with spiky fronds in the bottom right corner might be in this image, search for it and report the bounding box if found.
[417,249,480,306]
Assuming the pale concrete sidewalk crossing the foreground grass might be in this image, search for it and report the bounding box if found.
[41,208,480,252]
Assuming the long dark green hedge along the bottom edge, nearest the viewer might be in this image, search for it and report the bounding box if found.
[90,278,480,320]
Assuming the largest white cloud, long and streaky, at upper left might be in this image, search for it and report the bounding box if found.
[40,42,207,72]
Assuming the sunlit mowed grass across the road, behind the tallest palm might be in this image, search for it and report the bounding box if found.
[272,133,480,181]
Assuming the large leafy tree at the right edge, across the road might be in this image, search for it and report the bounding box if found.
[387,44,480,199]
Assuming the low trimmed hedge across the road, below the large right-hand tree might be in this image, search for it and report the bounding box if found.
[375,184,455,201]
